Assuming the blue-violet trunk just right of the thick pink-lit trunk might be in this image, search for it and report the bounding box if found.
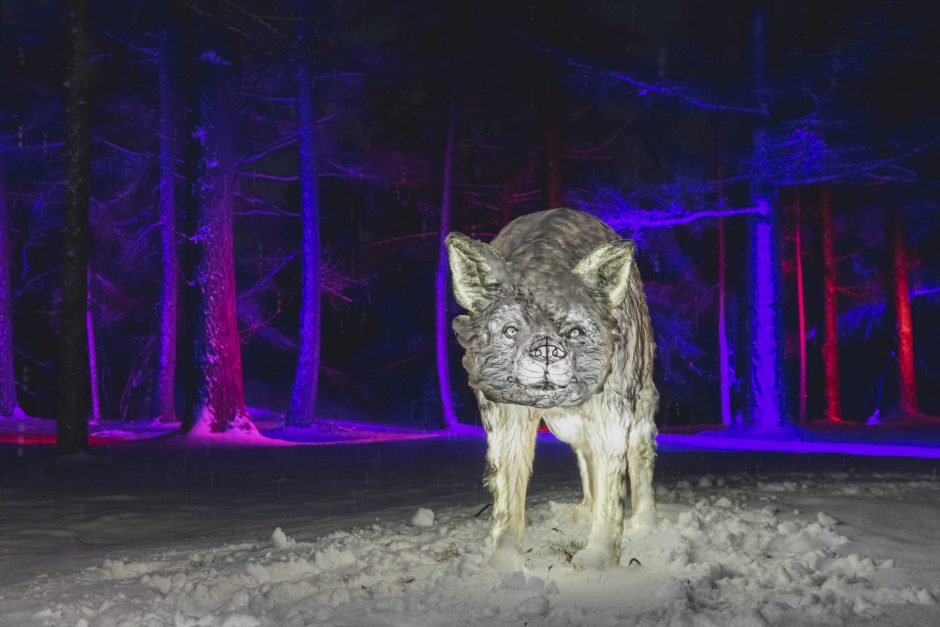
[287,0,321,427]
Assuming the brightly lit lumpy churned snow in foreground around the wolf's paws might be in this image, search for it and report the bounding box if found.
[18,478,940,627]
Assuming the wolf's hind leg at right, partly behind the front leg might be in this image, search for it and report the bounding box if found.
[627,397,656,529]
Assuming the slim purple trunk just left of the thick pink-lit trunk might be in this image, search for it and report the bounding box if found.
[157,0,179,423]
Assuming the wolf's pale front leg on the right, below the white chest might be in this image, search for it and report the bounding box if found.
[571,426,627,569]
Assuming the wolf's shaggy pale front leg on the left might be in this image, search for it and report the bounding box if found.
[478,396,538,572]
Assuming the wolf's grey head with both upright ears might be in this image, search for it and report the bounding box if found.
[447,233,634,409]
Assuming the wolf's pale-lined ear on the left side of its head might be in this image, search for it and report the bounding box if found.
[445,232,506,312]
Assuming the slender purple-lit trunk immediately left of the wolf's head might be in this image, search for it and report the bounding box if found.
[434,73,458,428]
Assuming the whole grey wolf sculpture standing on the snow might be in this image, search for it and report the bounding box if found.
[447,209,659,571]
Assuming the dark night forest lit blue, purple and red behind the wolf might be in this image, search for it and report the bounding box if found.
[0,0,940,451]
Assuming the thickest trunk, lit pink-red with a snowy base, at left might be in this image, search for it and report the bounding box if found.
[193,14,256,434]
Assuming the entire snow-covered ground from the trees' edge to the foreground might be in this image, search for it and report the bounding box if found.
[0,438,940,627]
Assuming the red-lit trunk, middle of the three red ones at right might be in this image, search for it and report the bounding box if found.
[819,184,842,422]
